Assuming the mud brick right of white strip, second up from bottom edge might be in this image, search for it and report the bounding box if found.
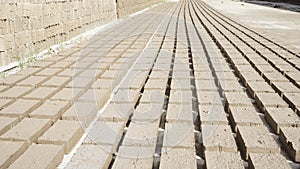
[83,121,126,151]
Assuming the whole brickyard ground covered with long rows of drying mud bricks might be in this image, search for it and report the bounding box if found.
[0,0,300,169]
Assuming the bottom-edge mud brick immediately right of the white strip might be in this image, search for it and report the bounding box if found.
[66,145,112,169]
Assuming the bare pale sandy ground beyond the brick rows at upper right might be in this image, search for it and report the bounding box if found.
[203,0,300,52]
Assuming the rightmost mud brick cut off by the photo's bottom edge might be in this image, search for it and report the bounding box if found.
[248,153,291,169]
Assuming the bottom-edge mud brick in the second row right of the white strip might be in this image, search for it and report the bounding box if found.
[112,146,154,169]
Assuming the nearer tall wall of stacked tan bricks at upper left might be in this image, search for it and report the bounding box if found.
[0,0,116,66]
